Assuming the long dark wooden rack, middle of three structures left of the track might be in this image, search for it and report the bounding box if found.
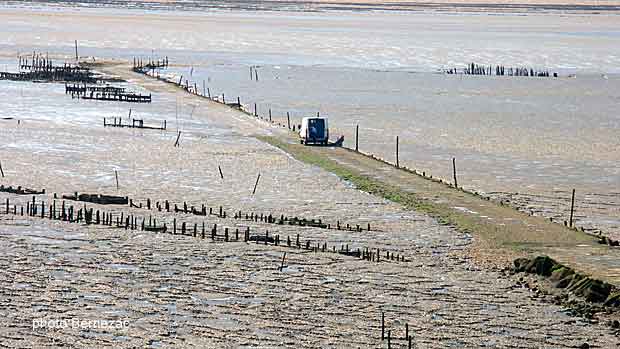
[65,84,152,103]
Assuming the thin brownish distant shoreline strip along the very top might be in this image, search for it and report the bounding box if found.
[1,0,620,14]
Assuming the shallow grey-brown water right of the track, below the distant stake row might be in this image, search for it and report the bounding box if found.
[159,64,620,237]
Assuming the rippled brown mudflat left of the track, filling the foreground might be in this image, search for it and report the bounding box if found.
[0,64,618,348]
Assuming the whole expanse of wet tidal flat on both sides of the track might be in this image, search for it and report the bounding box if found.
[0,3,620,348]
